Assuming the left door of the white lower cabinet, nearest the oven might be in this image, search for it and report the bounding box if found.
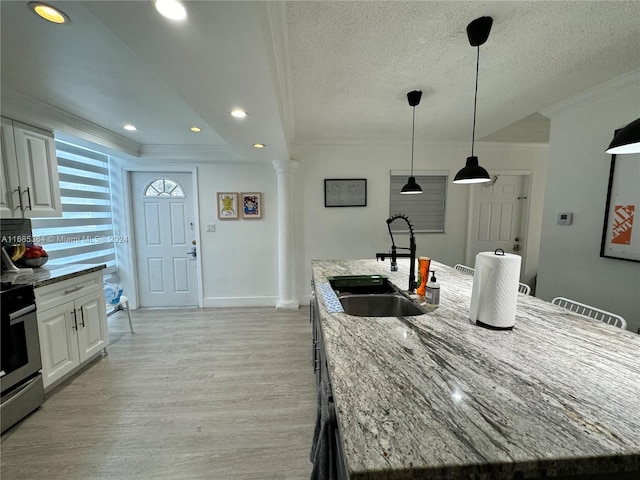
[38,302,80,387]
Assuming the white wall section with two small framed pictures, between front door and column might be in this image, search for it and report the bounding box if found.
[198,163,278,307]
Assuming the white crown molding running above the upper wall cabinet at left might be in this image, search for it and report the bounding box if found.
[2,87,140,157]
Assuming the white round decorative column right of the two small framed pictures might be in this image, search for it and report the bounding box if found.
[272,160,300,309]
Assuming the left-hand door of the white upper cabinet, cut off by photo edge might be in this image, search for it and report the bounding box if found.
[0,117,22,218]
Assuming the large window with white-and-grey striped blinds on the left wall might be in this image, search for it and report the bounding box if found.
[31,141,116,278]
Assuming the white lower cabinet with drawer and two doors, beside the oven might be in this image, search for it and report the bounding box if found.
[35,271,109,388]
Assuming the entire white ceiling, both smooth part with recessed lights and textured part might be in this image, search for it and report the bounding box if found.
[0,0,640,161]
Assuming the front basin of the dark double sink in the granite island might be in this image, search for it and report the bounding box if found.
[338,293,426,317]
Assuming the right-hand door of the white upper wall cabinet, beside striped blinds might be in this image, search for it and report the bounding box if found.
[13,122,62,218]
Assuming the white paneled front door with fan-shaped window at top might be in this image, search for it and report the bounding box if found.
[131,172,198,307]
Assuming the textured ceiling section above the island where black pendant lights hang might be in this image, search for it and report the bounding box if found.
[287,2,640,142]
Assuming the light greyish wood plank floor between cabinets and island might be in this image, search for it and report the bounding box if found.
[0,308,316,480]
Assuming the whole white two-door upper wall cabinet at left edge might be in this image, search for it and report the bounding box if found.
[0,117,62,218]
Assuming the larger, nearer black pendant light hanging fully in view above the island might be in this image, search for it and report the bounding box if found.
[453,17,493,184]
